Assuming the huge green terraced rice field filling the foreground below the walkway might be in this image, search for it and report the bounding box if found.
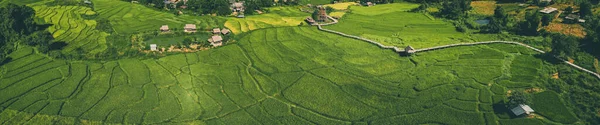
[0,27,580,124]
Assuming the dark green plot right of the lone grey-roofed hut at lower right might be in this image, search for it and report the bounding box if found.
[532,91,577,124]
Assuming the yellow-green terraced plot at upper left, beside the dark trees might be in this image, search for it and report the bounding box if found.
[32,5,109,55]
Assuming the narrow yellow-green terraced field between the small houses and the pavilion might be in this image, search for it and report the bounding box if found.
[225,7,310,34]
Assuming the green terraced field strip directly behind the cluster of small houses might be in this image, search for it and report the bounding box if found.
[94,0,224,34]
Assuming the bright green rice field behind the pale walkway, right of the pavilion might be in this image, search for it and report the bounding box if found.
[325,3,494,49]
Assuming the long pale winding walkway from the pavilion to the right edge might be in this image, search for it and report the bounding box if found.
[312,16,600,79]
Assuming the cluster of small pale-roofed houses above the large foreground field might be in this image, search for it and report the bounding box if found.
[150,24,231,51]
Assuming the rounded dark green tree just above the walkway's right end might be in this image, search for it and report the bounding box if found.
[551,34,579,57]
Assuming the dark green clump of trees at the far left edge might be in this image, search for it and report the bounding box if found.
[0,4,53,65]
